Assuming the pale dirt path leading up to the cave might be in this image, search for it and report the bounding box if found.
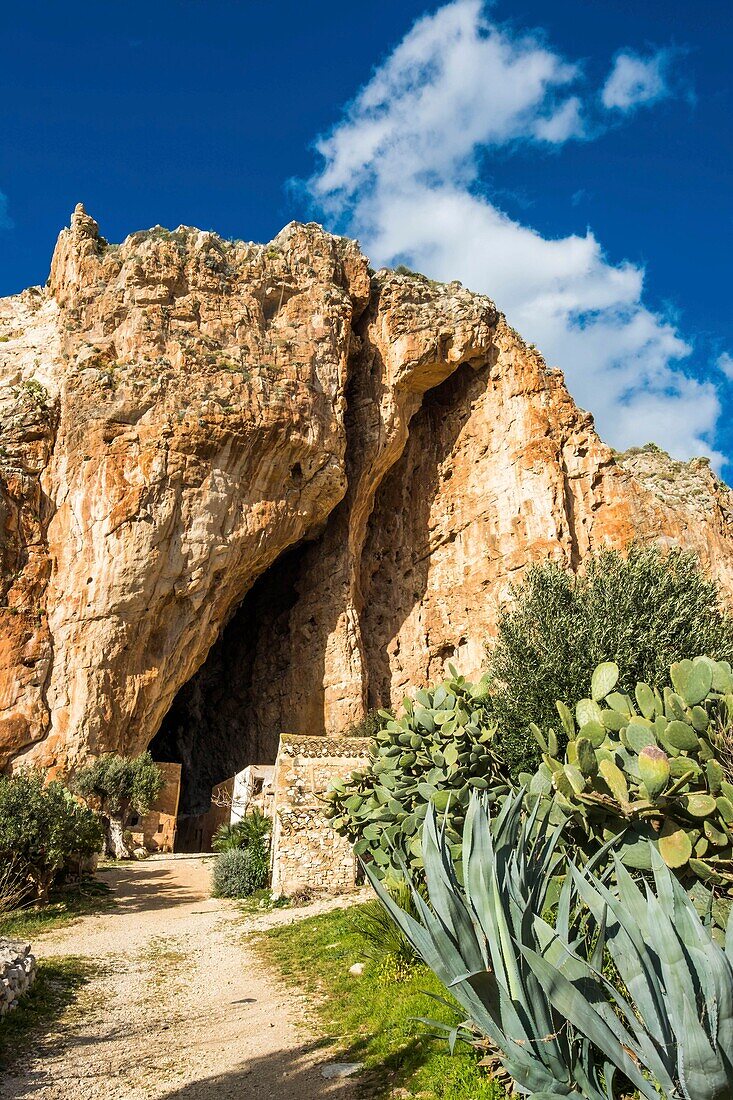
[0,859,363,1100]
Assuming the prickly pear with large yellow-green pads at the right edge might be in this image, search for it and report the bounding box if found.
[523,657,733,893]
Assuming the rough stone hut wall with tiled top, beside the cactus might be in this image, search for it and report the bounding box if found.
[272,734,370,897]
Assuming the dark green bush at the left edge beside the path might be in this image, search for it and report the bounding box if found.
[0,770,102,901]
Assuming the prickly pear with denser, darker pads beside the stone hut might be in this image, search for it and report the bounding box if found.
[325,669,508,879]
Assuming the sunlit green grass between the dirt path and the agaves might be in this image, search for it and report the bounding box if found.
[255,910,504,1100]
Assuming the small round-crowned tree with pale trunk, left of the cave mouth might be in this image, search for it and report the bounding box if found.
[74,752,163,859]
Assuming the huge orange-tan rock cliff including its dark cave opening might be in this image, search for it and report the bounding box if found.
[0,207,733,807]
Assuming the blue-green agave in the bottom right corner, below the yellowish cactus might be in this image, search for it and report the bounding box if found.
[523,847,733,1100]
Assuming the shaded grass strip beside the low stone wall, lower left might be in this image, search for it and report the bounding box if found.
[0,956,95,1069]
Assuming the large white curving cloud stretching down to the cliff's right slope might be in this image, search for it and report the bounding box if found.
[309,0,724,464]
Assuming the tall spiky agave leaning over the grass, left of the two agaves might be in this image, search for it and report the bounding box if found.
[367,793,652,1100]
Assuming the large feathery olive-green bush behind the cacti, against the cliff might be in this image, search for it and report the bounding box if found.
[489,545,733,776]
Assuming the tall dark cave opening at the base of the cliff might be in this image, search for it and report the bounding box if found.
[150,541,313,851]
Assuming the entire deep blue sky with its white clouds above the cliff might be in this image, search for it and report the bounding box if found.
[0,0,733,480]
